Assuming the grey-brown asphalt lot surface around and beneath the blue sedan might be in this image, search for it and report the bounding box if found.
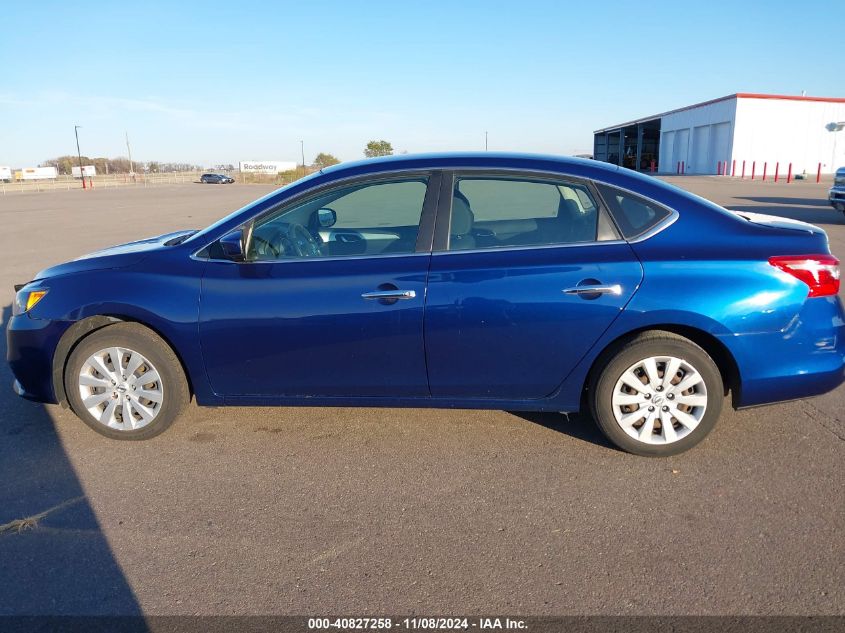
[0,177,845,615]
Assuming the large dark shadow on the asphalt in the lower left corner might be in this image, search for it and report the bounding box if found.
[0,306,148,620]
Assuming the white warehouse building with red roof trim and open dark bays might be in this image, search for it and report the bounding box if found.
[593,93,845,177]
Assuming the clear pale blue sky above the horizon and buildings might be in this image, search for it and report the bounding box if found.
[0,0,845,167]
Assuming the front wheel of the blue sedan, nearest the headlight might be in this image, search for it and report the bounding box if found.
[64,323,190,440]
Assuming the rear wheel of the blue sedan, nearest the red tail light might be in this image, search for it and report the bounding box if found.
[588,332,724,457]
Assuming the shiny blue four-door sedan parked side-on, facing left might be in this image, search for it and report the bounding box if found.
[7,153,845,456]
